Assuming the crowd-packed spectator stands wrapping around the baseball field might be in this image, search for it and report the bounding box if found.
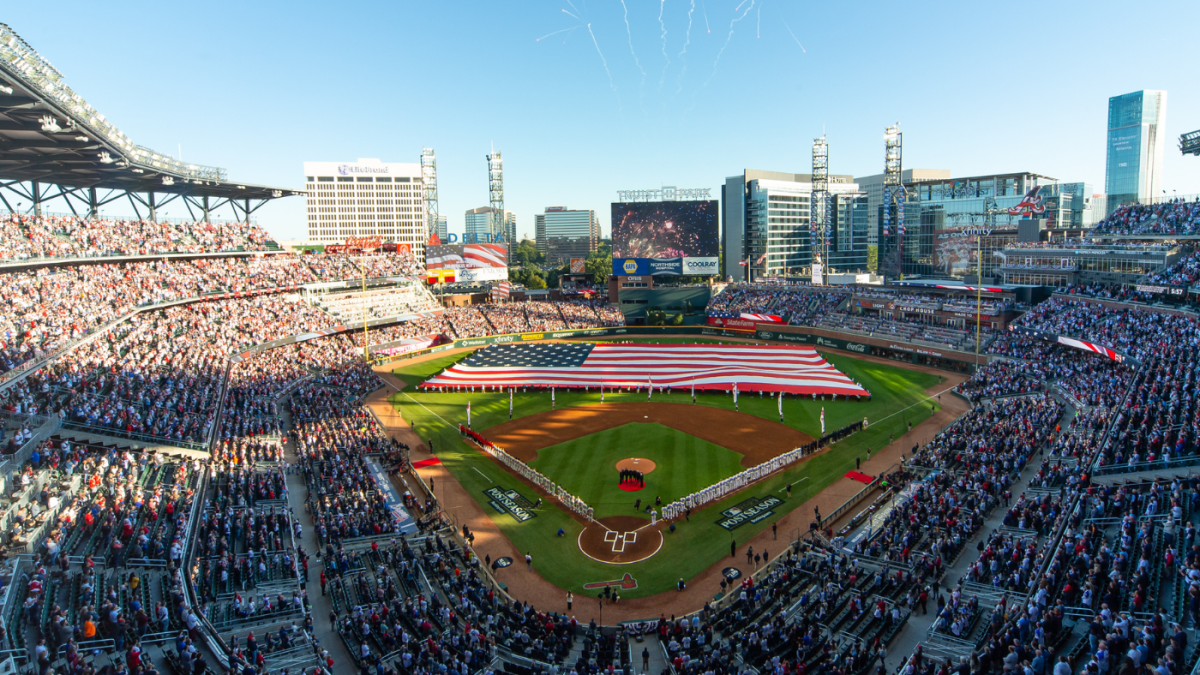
[0,212,1200,675]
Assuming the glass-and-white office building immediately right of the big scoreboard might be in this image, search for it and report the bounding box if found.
[721,169,869,280]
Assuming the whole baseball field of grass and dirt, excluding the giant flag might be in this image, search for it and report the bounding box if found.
[391,339,942,598]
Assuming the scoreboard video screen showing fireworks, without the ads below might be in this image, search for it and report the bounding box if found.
[612,199,720,258]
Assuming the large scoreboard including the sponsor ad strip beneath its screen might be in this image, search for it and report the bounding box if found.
[612,199,720,275]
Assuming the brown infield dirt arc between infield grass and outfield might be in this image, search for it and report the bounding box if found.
[481,404,812,468]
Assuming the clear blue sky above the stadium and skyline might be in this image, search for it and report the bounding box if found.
[0,0,1200,239]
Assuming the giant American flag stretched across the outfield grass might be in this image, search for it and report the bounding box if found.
[420,344,869,396]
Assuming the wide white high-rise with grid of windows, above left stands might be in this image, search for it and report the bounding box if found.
[304,157,426,261]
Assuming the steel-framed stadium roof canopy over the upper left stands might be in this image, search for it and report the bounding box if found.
[0,23,304,215]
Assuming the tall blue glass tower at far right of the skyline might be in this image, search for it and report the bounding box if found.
[1104,89,1166,213]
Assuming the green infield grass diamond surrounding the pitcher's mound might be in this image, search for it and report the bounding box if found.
[529,423,743,519]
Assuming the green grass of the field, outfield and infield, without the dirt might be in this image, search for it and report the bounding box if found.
[391,338,942,597]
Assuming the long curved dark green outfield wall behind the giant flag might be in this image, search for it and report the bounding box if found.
[374,323,988,372]
